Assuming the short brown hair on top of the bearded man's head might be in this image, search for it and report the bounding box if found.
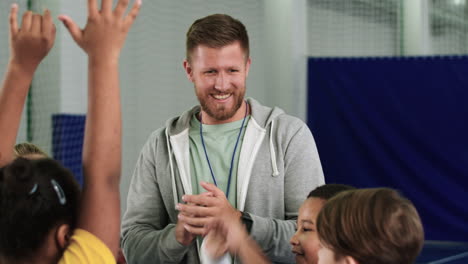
[186,14,249,62]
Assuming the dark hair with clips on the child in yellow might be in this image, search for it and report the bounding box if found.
[0,158,80,260]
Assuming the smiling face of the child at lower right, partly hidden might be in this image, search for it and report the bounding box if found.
[290,197,325,264]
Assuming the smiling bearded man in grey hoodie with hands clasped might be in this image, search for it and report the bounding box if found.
[122,14,324,263]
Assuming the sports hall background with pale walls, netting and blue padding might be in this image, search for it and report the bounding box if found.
[0,0,468,263]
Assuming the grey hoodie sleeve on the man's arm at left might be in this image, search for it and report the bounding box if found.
[122,133,190,263]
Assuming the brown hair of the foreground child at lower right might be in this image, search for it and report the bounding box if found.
[317,188,424,264]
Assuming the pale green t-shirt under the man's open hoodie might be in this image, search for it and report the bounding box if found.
[189,113,250,208]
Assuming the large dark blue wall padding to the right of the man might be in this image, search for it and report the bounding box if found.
[308,56,468,241]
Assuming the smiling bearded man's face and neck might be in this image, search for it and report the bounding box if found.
[184,42,250,124]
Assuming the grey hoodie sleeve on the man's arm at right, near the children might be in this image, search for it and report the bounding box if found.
[250,119,325,263]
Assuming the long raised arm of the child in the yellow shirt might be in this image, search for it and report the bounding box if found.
[59,0,141,256]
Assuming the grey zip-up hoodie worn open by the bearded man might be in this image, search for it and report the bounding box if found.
[122,99,324,264]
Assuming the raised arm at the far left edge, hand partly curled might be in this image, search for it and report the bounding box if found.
[0,4,55,167]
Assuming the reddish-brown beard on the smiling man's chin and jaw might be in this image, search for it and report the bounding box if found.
[195,88,245,121]
